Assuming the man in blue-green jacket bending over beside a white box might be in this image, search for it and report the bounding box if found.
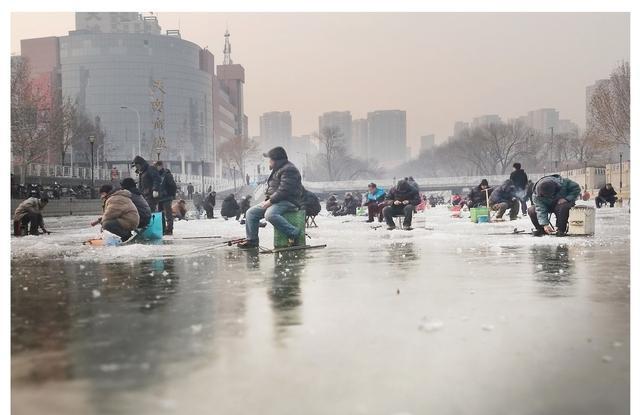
[528,174,580,236]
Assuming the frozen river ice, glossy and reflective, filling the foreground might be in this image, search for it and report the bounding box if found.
[11,207,630,415]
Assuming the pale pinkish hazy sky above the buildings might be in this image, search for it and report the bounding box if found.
[11,13,629,156]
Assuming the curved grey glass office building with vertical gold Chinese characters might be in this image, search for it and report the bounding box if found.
[60,31,213,173]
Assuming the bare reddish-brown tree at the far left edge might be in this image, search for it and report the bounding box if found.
[11,59,50,183]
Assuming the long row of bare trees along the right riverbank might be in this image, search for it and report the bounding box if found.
[394,62,630,177]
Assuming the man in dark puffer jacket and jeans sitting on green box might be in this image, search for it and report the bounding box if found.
[238,147,304,249]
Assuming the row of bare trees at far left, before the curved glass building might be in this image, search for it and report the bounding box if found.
[11,59,106,181]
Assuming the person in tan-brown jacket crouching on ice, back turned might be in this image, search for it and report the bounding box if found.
[91,184,140,242]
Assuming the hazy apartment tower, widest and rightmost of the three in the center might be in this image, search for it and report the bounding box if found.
[367,110,407,165]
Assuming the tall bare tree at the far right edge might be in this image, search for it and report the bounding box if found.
[589,61,631,147]
